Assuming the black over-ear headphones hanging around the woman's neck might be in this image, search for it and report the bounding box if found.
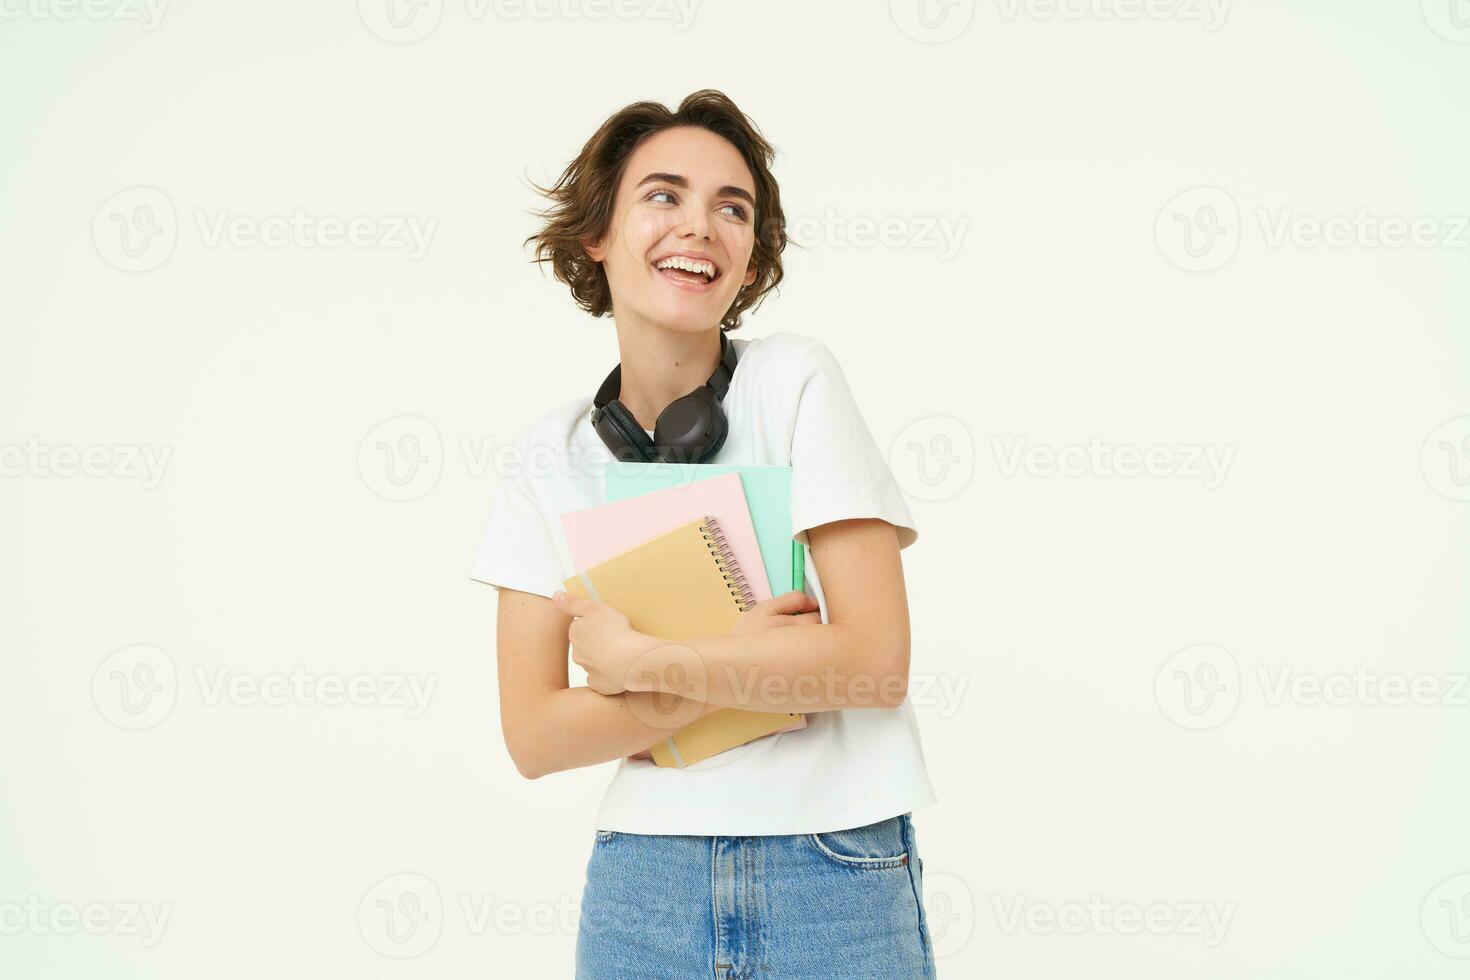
[592,331,736,463]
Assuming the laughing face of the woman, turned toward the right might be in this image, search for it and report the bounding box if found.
[584,126,756,332]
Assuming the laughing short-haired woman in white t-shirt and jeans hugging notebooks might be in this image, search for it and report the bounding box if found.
[473,90,935,980]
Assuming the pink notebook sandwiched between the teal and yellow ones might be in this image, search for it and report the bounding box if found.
[562,473,770,602]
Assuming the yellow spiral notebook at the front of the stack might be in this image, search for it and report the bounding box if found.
[563,517,806,768]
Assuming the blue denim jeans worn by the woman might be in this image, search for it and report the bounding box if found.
[576,814,935,980]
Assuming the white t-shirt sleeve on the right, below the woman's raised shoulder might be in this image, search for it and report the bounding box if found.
[791,342,919,550]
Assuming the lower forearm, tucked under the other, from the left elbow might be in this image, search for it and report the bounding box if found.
[507,688,717,779]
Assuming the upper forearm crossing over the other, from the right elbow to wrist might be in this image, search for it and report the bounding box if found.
[628,623,908,711]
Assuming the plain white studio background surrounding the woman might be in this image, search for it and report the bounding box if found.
[0,0,1470,980]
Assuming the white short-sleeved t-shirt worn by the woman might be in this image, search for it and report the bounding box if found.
[470,332,935,836]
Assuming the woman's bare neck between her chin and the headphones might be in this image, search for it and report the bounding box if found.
[614,317,720,429]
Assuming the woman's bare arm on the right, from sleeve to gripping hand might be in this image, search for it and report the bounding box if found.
[557,517,910,711]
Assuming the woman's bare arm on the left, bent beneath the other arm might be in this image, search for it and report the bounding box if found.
[495,588,719,779]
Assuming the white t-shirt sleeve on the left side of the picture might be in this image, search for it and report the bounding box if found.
[469,455,566,598]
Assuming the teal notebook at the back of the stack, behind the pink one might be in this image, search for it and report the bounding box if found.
[606,460,806,595]
